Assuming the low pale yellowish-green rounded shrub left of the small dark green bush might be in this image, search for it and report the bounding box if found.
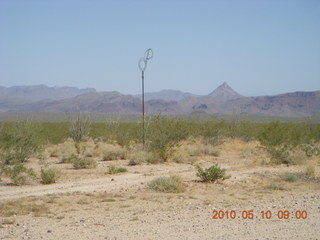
[148,175,185,193]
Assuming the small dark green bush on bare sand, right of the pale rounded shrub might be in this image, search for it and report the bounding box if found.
[196,164,230,182]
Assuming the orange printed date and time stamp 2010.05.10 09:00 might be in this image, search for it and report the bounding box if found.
[212,210,308,219]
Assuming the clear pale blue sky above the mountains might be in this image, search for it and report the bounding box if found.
[0,0,320,96]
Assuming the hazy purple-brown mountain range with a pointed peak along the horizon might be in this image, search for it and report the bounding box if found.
[0,83,320,117]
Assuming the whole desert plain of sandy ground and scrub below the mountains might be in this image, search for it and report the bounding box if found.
[0,116,320,239]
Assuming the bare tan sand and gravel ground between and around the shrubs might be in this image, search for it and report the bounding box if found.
[0,139,320,240]
